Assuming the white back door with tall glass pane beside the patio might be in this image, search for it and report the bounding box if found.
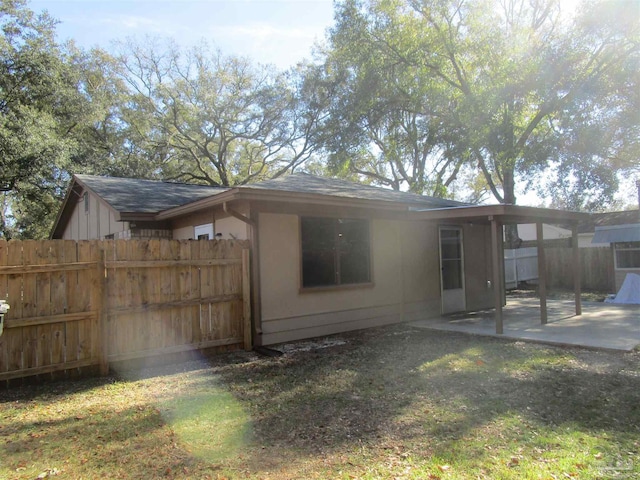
[440,227,465,313]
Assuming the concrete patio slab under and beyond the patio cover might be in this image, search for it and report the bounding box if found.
[409,298,640,351]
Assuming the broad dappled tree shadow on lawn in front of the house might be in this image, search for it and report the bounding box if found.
[212,326,640,470]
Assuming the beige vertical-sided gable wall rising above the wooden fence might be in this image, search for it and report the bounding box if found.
[62,188,129,240]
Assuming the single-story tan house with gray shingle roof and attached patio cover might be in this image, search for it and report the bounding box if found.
[51,174,583,345]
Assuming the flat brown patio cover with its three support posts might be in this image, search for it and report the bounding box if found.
[409,204,588,334]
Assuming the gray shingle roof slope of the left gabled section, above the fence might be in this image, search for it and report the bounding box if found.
[75,175,229,213]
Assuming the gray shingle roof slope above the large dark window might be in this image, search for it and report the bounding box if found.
[245,173,469,208]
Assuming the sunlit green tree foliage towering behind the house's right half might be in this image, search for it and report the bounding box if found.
[323,0,640,209]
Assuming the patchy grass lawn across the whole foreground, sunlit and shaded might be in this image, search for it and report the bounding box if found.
[0,325,640,480]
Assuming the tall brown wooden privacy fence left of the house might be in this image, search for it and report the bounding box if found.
[0,240,251,380]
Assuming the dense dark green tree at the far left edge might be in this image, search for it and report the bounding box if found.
[0,0,126,238]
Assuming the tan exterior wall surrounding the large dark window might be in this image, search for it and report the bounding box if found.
[260,213,440,344]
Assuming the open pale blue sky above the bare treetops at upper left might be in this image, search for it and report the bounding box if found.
[29,0,333,68]
